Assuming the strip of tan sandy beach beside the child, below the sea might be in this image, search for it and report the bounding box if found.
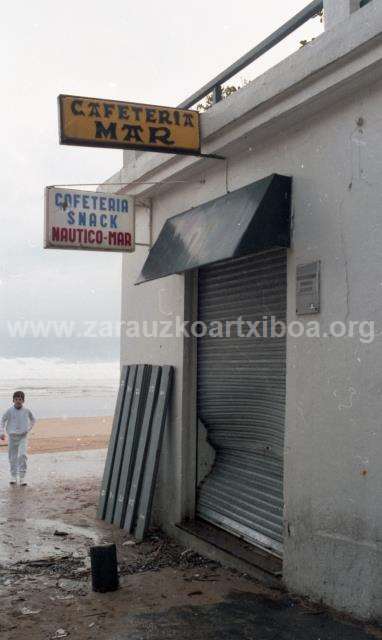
[0,417,113,454]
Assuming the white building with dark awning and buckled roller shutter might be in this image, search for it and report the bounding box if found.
[105,0,382,619]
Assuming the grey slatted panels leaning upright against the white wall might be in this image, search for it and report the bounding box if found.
[98,364,174,541]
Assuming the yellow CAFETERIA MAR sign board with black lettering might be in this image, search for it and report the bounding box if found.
[58,95,200,154]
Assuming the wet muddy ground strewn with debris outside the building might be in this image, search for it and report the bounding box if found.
[0,451,382,640]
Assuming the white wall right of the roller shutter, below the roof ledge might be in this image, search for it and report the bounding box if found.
[272,84,382,618]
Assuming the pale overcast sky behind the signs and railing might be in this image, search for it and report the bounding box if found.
[0,0,322,360]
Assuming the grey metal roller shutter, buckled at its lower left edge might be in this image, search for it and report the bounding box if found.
[197,250,286,553]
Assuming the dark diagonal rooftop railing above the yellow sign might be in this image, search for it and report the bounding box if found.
[178,0,324,109]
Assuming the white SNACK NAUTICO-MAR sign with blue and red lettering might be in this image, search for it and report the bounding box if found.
[44,187,135,252]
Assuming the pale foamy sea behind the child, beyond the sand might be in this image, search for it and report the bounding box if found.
[0,357,120,419]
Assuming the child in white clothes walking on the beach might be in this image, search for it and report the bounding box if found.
[0,391,36,487]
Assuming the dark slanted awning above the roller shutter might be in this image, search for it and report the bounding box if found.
[136,174,292,284]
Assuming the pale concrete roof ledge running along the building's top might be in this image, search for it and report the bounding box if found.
[103,2,382,195]
